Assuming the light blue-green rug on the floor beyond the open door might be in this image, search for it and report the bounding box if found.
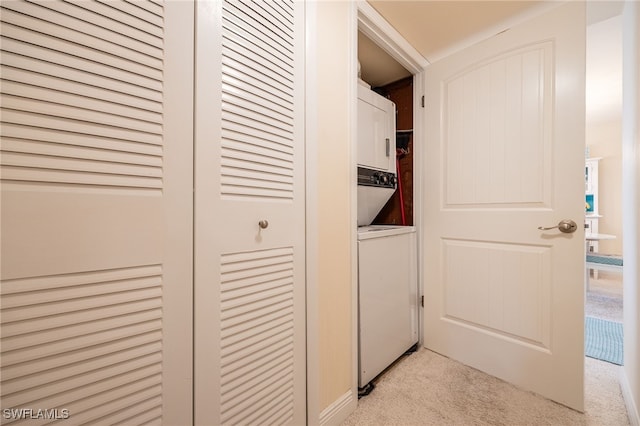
[584,317,623,365]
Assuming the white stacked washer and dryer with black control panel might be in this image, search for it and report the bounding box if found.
[358,80,418,394]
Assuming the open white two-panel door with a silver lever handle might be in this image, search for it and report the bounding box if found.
[424,2,585,410]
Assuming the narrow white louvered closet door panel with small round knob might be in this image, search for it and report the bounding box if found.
[195,0,306,425]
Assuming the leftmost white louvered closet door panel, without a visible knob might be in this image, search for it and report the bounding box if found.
[0,0,194,425]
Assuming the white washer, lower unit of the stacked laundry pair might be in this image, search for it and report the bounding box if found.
[358,225,418,388]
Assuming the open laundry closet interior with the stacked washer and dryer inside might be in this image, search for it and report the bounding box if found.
[357,31,420,397]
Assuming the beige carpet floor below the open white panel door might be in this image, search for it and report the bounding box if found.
[342,349,629,426]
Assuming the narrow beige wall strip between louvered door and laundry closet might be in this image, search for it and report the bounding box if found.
[316,1,356,411]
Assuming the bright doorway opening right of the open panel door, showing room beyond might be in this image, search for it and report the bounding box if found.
[585,15,624,420]
